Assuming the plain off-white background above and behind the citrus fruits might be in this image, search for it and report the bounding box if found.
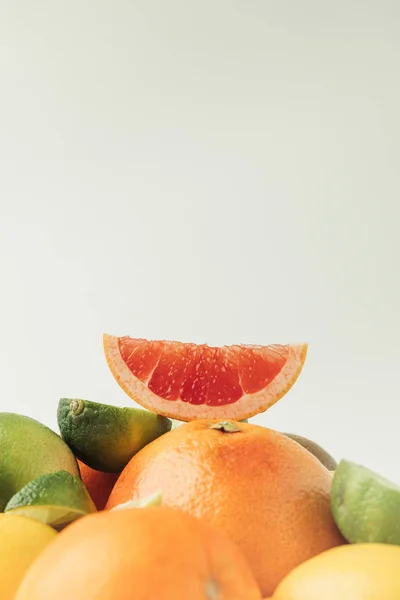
[0,0,400,482]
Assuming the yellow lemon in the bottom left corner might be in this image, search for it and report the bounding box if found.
[0,514,57,600]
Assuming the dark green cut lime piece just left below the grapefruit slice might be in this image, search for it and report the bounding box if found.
[57,398,171,473]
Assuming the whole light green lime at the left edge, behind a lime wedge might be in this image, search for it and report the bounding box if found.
[0,413,79,512]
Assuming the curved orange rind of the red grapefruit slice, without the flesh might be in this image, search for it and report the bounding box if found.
[103,333,308,421]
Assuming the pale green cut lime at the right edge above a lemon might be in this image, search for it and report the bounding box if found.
[331,460,400,545]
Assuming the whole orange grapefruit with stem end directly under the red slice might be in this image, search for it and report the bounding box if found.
[106,420,345,595]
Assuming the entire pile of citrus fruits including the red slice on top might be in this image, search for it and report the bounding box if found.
[0,335,400,600]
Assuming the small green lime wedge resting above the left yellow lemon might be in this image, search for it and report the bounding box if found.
[4,471,96,529]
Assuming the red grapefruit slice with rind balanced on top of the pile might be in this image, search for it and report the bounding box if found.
[104,334,307,421]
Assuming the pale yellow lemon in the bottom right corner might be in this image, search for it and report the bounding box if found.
[272,543,400,600]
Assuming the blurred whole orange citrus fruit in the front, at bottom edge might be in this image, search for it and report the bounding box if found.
[16,507,261,600]
